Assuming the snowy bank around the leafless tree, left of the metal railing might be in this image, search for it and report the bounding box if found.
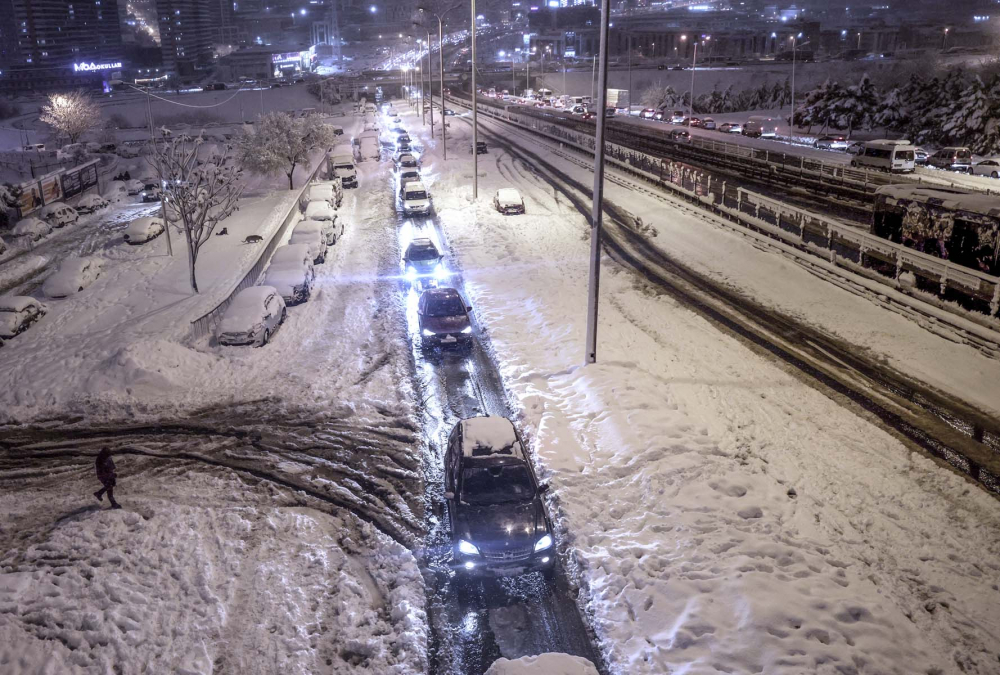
[0,150,323,420]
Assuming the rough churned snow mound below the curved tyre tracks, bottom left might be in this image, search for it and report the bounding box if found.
[0,460,426,675]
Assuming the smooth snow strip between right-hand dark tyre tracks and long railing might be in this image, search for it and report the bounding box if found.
[466,108,1000,415]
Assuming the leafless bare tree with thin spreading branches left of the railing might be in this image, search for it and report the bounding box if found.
[149,129,243,293]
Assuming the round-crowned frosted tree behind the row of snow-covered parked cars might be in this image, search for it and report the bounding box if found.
[237,112,335,190]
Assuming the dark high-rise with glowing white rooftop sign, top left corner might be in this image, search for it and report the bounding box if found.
[0,0,122,91]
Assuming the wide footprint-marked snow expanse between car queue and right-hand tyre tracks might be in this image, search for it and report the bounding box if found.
[410,116,1000,675]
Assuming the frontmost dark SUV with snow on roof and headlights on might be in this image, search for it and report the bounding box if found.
[444,417,555,578]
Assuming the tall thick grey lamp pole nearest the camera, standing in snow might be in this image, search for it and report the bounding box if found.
[584,0,612,363]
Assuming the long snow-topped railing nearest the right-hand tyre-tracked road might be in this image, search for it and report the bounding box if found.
[472,101,1000,330]
